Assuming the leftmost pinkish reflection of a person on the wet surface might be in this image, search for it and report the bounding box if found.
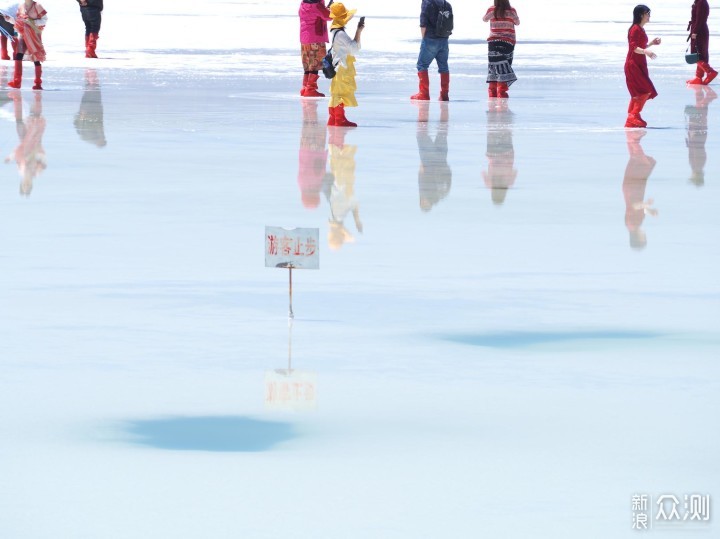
[5,90,47,196]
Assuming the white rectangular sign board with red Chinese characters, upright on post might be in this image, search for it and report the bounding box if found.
[265,226,320,269]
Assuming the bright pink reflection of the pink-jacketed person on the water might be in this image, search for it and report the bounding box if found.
[298,99,328,208]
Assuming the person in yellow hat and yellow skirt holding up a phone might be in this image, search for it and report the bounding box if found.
[328,3,365,127]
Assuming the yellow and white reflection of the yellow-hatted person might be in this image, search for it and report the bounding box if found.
[323,127,363,249]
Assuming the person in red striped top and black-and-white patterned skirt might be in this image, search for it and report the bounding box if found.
[483,0,520,97]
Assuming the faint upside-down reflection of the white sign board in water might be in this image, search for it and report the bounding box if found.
[265,369,317,412]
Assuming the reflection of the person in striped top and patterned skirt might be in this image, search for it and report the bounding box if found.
[483,99,518,206]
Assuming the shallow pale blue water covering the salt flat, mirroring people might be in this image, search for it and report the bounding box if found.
[0,2,720,538]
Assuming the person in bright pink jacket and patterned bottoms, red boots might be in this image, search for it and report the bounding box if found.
[298,0,330,97]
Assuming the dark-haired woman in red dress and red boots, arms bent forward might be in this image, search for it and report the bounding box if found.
[625,4,660,127]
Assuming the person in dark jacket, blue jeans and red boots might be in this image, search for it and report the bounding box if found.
[410,0,452,101]
